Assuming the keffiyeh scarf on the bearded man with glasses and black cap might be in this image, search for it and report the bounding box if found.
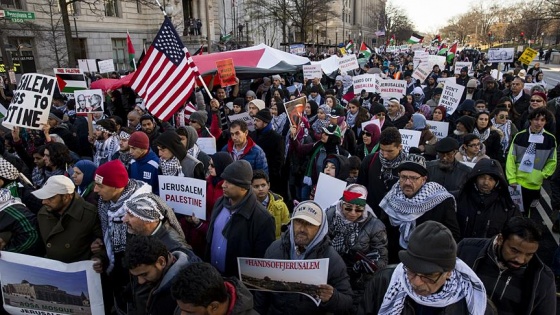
[379,182,455,248]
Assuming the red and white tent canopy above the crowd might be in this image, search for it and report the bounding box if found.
[192,44,310,79]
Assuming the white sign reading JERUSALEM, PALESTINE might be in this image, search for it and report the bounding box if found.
[158,175,206,220]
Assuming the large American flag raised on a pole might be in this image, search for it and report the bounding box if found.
[131,17,199,120]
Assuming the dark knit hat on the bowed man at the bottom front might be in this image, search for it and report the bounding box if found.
[399,221,457,274]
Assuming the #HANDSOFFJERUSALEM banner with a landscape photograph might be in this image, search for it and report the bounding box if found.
[237,257,329,306]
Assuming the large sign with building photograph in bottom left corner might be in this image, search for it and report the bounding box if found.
[0,251,104,315]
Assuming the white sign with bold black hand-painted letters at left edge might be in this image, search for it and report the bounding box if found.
[2,73,56,130]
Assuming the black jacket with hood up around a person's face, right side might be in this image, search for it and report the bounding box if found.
[457,159,521,238]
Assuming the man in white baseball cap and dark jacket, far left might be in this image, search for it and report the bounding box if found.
[32,175,105,263]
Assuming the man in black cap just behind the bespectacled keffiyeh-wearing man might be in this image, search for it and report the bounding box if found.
[426,137,471,193]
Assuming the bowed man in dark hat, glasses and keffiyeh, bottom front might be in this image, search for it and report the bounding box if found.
[358,221,490,315]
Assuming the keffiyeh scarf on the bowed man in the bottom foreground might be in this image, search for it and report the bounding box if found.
[379,258,486,315]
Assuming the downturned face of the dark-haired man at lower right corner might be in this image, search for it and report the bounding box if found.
[497,234,539,269]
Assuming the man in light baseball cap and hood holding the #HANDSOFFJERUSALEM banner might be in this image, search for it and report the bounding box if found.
[255,200,352,314]
